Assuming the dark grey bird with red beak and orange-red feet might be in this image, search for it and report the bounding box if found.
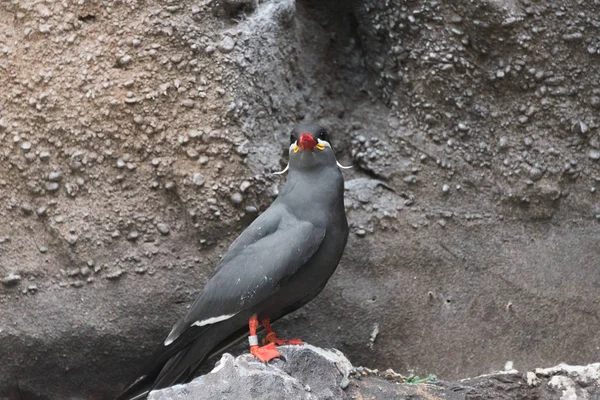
[116,122,350,400]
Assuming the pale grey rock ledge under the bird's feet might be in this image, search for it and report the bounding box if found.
[148,345,600,400]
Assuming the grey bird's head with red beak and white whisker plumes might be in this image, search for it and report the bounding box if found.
[282,122,349,172]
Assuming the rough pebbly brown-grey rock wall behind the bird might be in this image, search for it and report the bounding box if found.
[0,0,600,399]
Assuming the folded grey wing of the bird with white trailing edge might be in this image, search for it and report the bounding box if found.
[165,206,325,345]
